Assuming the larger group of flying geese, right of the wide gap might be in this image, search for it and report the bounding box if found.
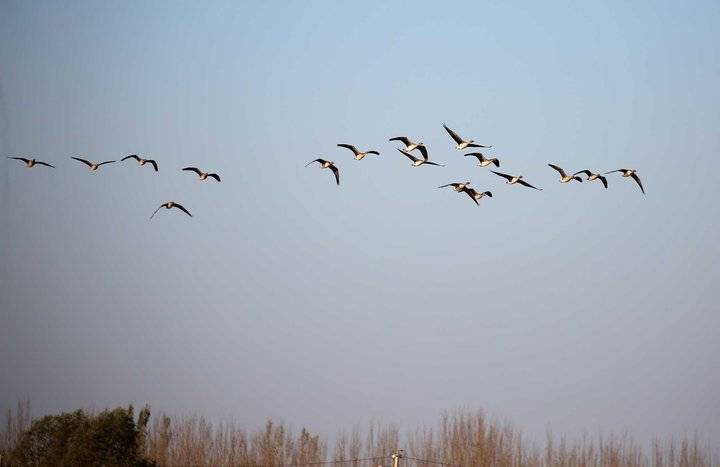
[305,124,645,205]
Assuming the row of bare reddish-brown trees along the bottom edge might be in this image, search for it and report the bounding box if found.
[0,401,720,467]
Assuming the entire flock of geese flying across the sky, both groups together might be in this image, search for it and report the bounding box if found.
[8,124,645,219]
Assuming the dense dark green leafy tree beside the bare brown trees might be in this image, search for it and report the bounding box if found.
[12,406,154,467]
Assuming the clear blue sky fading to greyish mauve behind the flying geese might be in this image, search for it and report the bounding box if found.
[0,0,720,446]
